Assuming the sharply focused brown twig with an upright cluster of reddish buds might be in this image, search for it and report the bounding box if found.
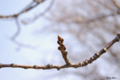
[0,34,120,70]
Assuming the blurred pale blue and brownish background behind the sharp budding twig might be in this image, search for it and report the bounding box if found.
[0,0,120,80]
